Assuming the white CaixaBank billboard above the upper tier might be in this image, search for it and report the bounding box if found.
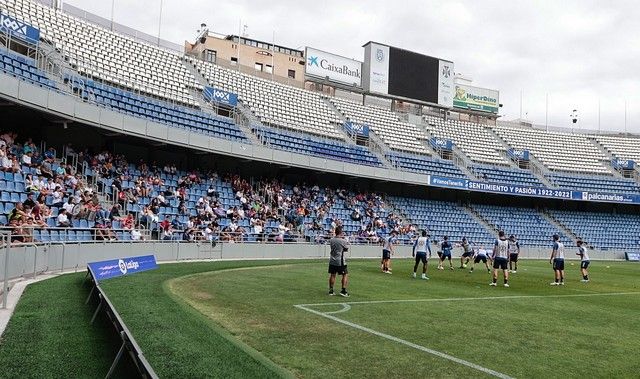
[304,47,362,87]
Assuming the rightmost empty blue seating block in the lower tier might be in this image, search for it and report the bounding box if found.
[549,210,640,251]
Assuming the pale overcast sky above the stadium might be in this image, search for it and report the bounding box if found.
[65,0,640,133]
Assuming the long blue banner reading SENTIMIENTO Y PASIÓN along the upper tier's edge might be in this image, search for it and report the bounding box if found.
[429,175,640,204]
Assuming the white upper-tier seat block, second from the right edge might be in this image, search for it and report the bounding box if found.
[493,124,611,174]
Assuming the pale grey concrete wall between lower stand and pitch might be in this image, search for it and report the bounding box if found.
[0,241,624,280]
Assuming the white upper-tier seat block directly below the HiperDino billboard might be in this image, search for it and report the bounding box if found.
[425,117,508,165]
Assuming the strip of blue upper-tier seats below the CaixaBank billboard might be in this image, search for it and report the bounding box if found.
[253,127,382,166]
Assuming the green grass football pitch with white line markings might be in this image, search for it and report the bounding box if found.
[0,259,640,378]
